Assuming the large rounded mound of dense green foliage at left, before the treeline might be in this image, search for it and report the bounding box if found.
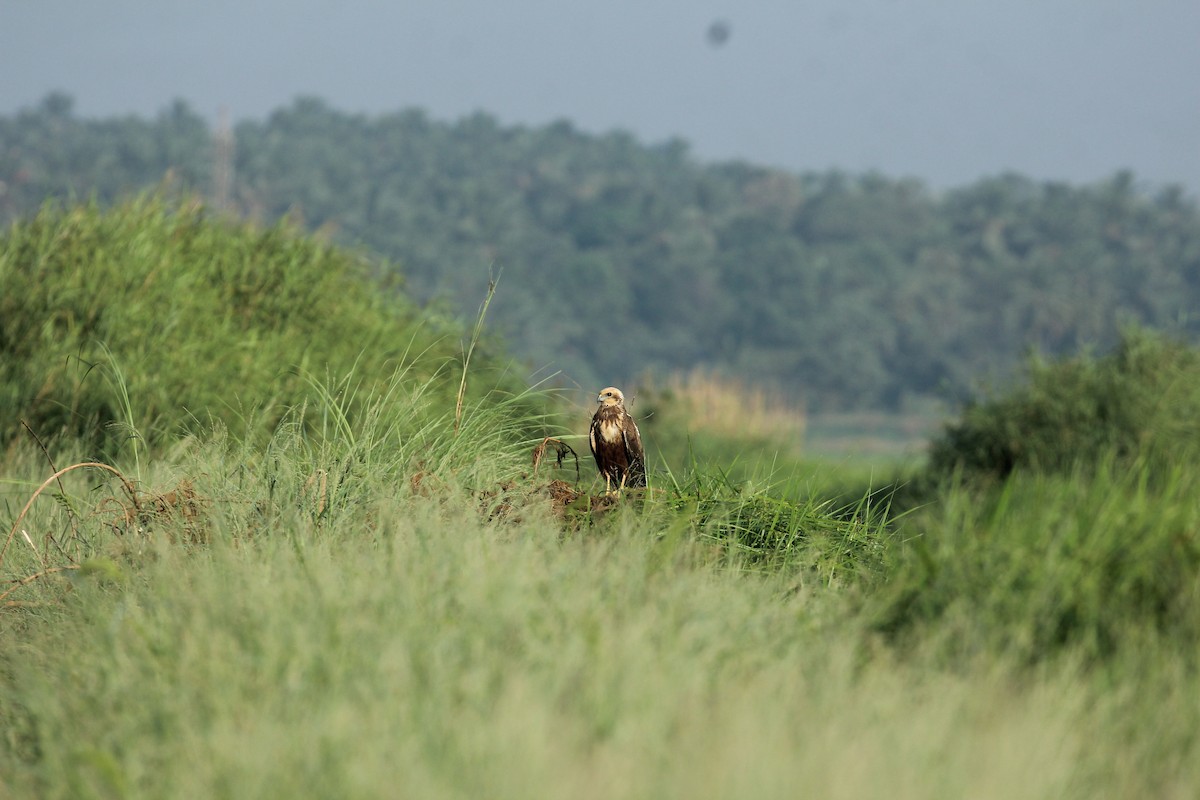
[0,198,533,451]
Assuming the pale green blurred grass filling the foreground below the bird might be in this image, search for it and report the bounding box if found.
[0,429,1200,798]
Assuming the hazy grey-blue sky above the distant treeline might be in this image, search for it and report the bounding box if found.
[7,0,1200,196]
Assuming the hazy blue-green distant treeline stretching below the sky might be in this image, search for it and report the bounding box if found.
[0,94,1200,408]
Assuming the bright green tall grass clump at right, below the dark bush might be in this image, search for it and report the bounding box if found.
[871,459,1200,662]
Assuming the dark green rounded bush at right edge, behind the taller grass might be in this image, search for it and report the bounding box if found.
[930,329,1200,477]
